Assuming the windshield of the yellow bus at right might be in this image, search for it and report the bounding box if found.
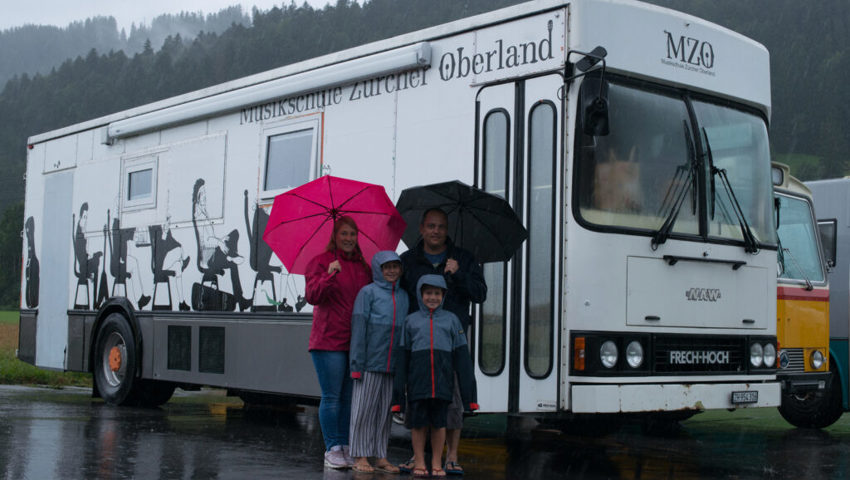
[777,195,824,283]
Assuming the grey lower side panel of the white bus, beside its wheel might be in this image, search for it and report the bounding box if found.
[67,312,321,397]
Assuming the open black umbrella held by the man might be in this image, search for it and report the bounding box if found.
[396,180,528,263]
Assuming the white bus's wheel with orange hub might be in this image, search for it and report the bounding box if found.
[94,313,140,405]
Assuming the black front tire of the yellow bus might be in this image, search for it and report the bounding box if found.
[779,368,843,428]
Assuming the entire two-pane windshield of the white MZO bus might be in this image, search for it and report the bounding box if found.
[575,82,776,245]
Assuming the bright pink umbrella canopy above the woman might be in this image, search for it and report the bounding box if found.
[263,175,405,274]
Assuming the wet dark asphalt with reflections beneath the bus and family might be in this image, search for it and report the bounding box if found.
[0,386,850,480]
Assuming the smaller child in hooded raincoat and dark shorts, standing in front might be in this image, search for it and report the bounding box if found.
[392,274,478,477]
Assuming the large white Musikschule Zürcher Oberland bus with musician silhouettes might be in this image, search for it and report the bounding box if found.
[19,0,780,416]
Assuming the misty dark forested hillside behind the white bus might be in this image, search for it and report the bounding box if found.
[0,0,850,305]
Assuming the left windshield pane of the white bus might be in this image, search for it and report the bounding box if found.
[577,83,699,235]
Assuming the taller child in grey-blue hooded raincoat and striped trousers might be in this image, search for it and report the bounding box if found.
[349,251,408,473]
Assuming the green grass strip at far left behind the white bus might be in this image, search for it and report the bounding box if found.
[0,311,91,388]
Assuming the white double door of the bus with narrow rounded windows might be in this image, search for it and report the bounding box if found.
[474,74,564,412]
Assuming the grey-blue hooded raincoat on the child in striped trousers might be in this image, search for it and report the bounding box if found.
[349,250,409,378]
